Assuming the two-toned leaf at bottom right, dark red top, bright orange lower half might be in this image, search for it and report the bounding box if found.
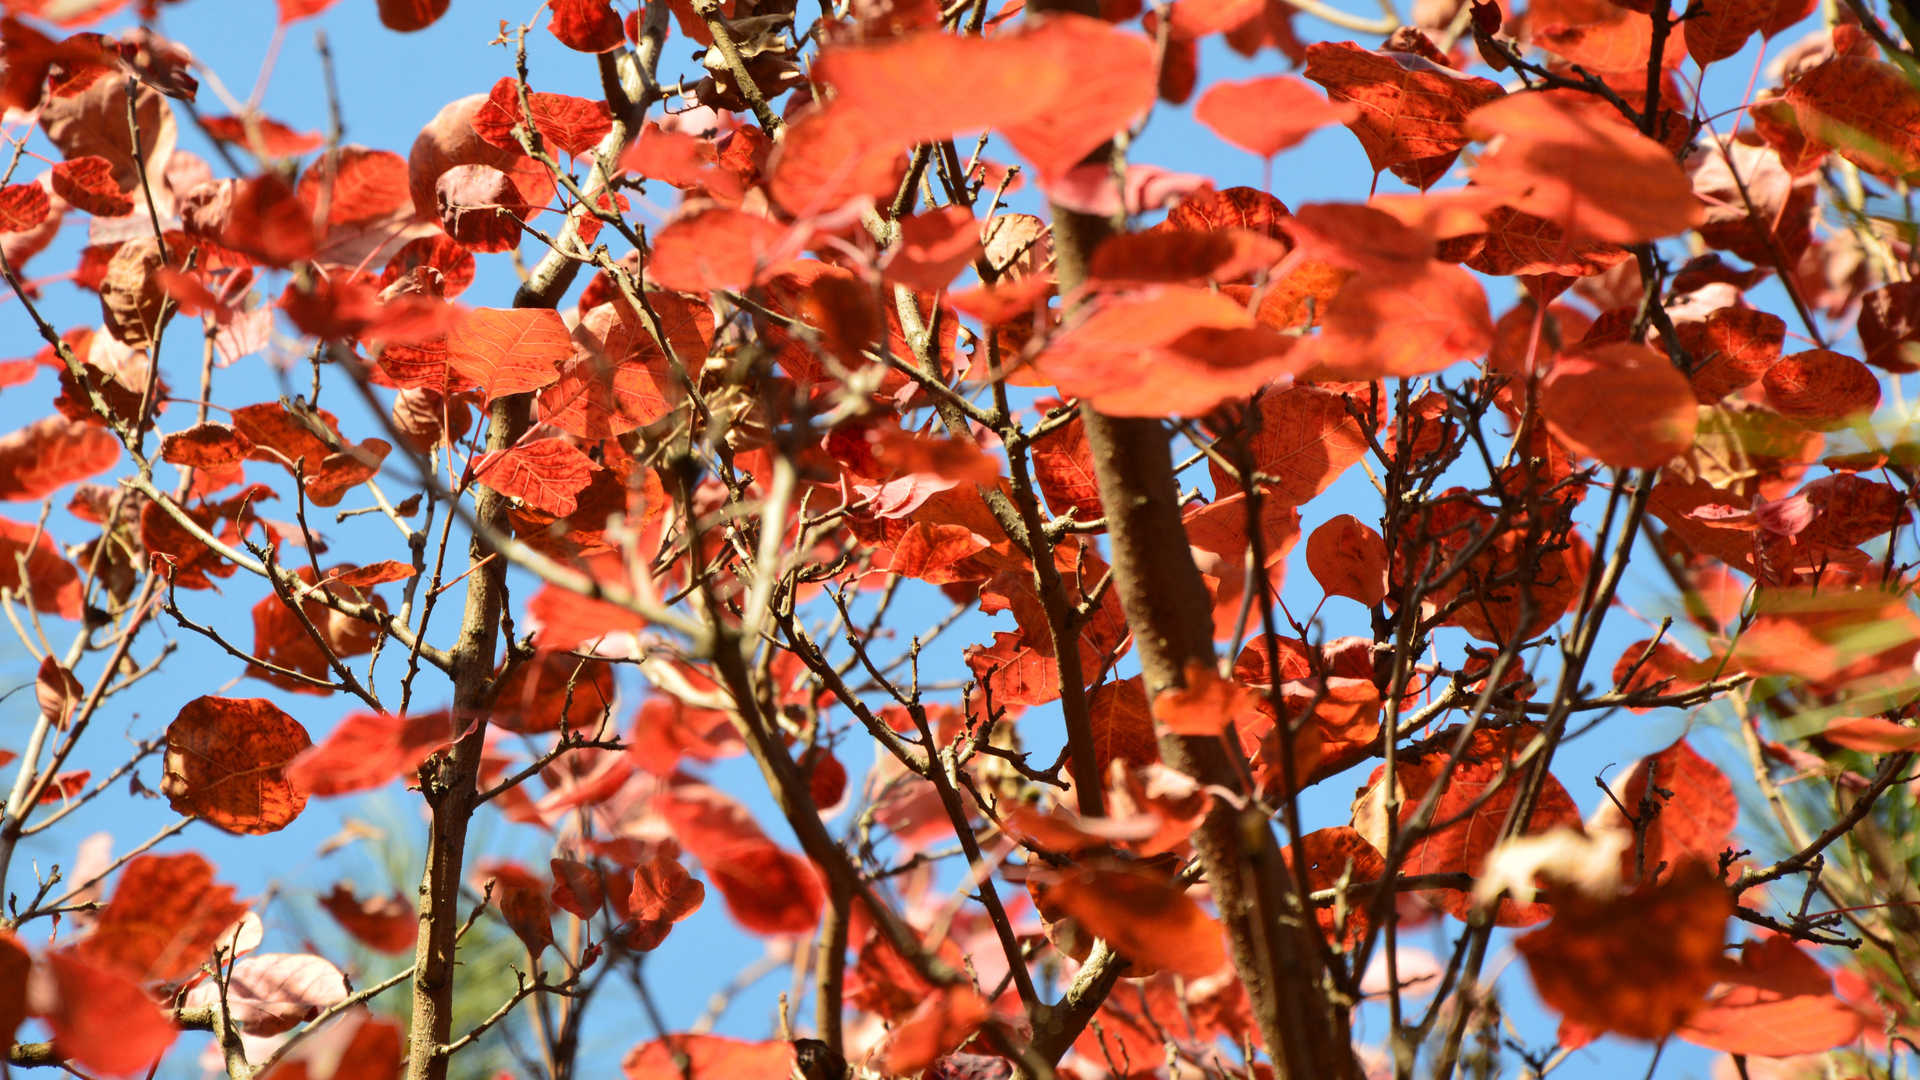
[1674,936,1866,1057]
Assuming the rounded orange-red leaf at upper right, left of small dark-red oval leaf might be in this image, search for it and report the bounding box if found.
[1540,342,1697,469]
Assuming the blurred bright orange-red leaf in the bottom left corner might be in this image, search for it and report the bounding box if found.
[40,949,179,1076]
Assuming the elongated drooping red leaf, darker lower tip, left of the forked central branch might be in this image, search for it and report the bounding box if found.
[653,782,824,934]
